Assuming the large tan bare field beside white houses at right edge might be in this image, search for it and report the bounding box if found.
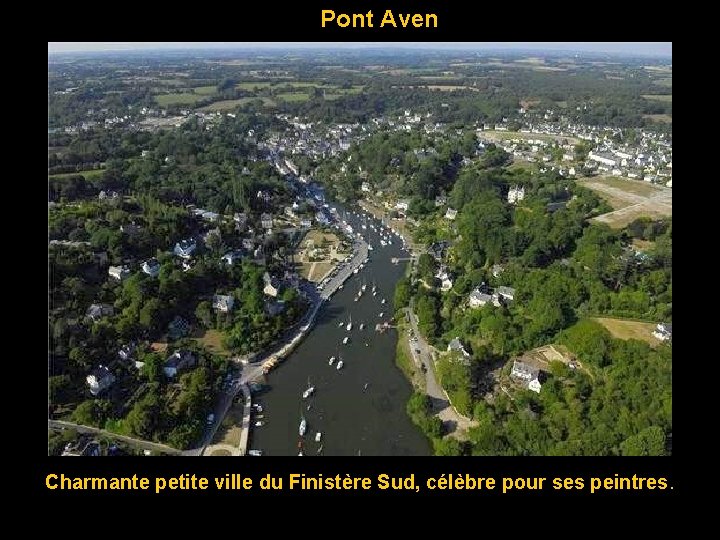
[581,177,672,229]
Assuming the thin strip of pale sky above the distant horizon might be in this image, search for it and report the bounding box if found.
[48,41,672,57]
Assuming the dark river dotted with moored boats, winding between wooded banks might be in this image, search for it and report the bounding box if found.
[249,206,431,456]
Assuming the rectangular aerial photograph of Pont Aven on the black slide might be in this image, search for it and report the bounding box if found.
[48,42,672,457]
